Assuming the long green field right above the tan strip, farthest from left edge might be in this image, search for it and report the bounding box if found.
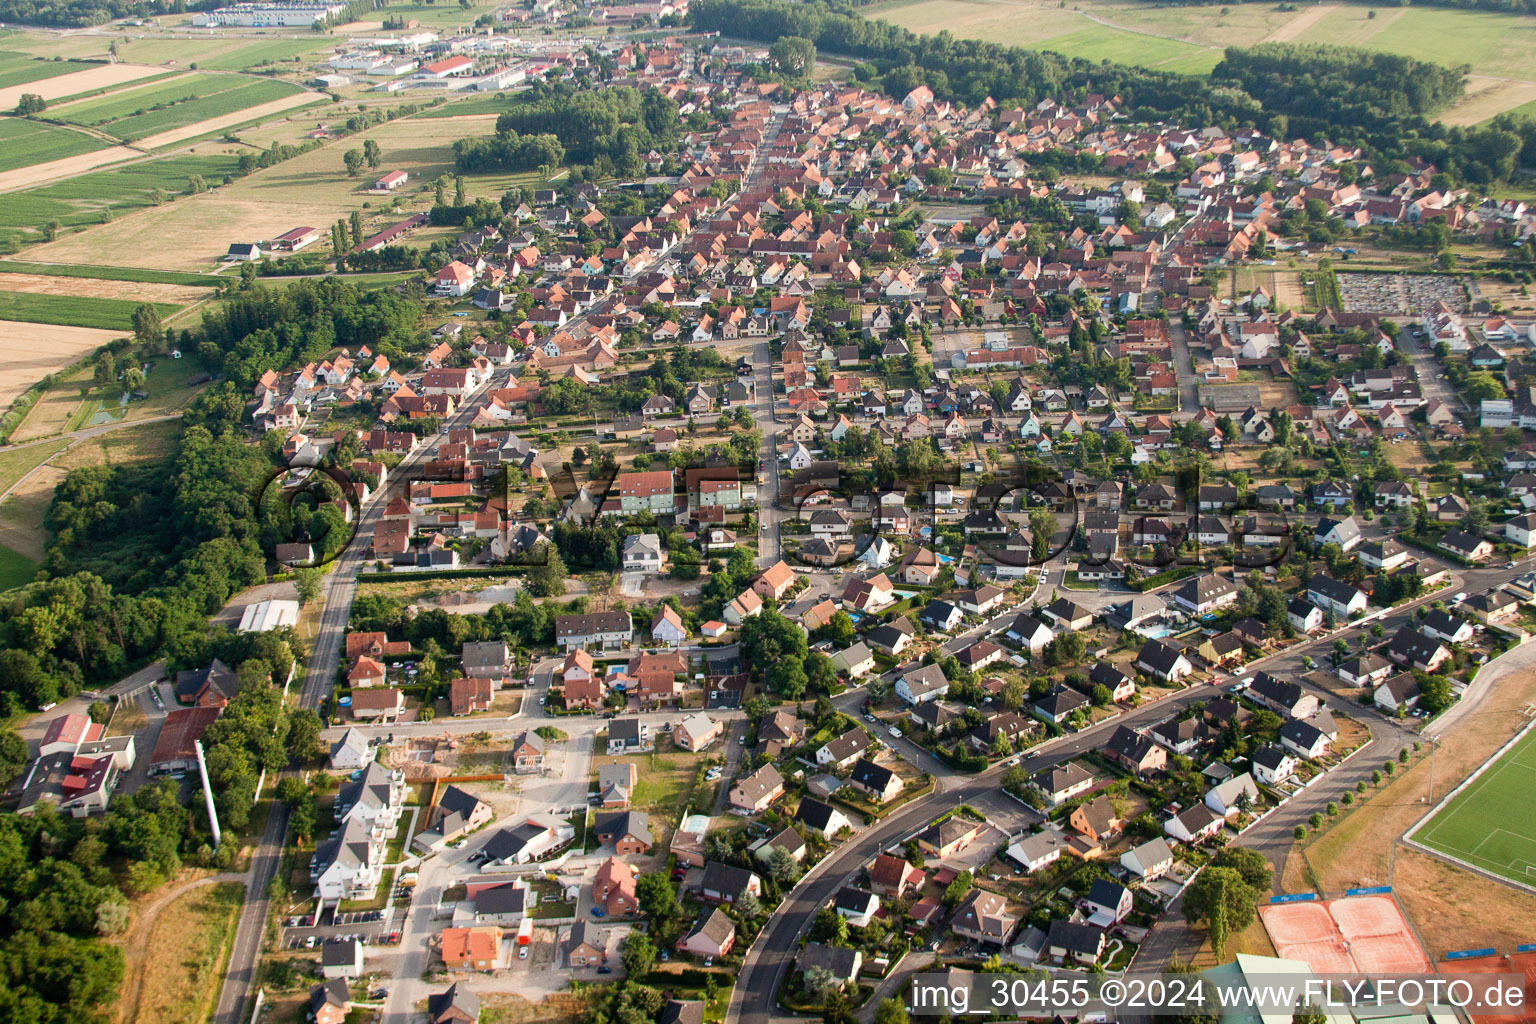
[57,72,303,141]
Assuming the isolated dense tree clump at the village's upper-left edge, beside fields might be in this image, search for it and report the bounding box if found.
[453,83,682,177]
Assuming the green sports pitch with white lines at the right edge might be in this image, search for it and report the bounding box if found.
[1415,731,1536,886]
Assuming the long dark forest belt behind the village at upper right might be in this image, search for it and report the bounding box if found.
[690,0,1536,186]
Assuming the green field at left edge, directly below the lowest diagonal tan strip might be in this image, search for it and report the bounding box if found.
[0,155,240,230]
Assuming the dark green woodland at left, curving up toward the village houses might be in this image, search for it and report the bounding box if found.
[0,279,421,714]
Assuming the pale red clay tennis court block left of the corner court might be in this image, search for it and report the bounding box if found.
[1258,897,1430,975]
